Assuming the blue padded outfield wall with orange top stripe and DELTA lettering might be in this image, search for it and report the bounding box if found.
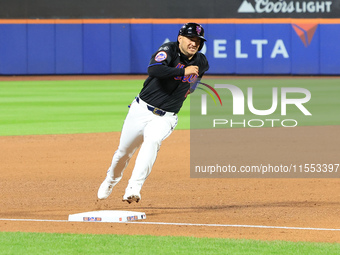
[0,19,340,75]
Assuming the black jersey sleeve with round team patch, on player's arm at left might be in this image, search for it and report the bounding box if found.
[148,44,184,79]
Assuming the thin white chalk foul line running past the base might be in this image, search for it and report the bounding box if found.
[0,218,340,231]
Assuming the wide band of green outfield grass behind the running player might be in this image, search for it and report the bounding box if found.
[0,78,340,136]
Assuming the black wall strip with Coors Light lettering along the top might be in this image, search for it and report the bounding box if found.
[0,0,340,19]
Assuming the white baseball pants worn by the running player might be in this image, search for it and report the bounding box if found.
[107,99,178,191]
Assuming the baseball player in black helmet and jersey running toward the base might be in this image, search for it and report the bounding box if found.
[98,23,209,203]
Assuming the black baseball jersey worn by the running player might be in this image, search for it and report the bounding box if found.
[139,42,209,113]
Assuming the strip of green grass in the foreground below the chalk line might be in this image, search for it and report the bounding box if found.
[0,232,340,255]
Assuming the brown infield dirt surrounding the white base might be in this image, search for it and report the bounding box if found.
[0,127,340,242]
